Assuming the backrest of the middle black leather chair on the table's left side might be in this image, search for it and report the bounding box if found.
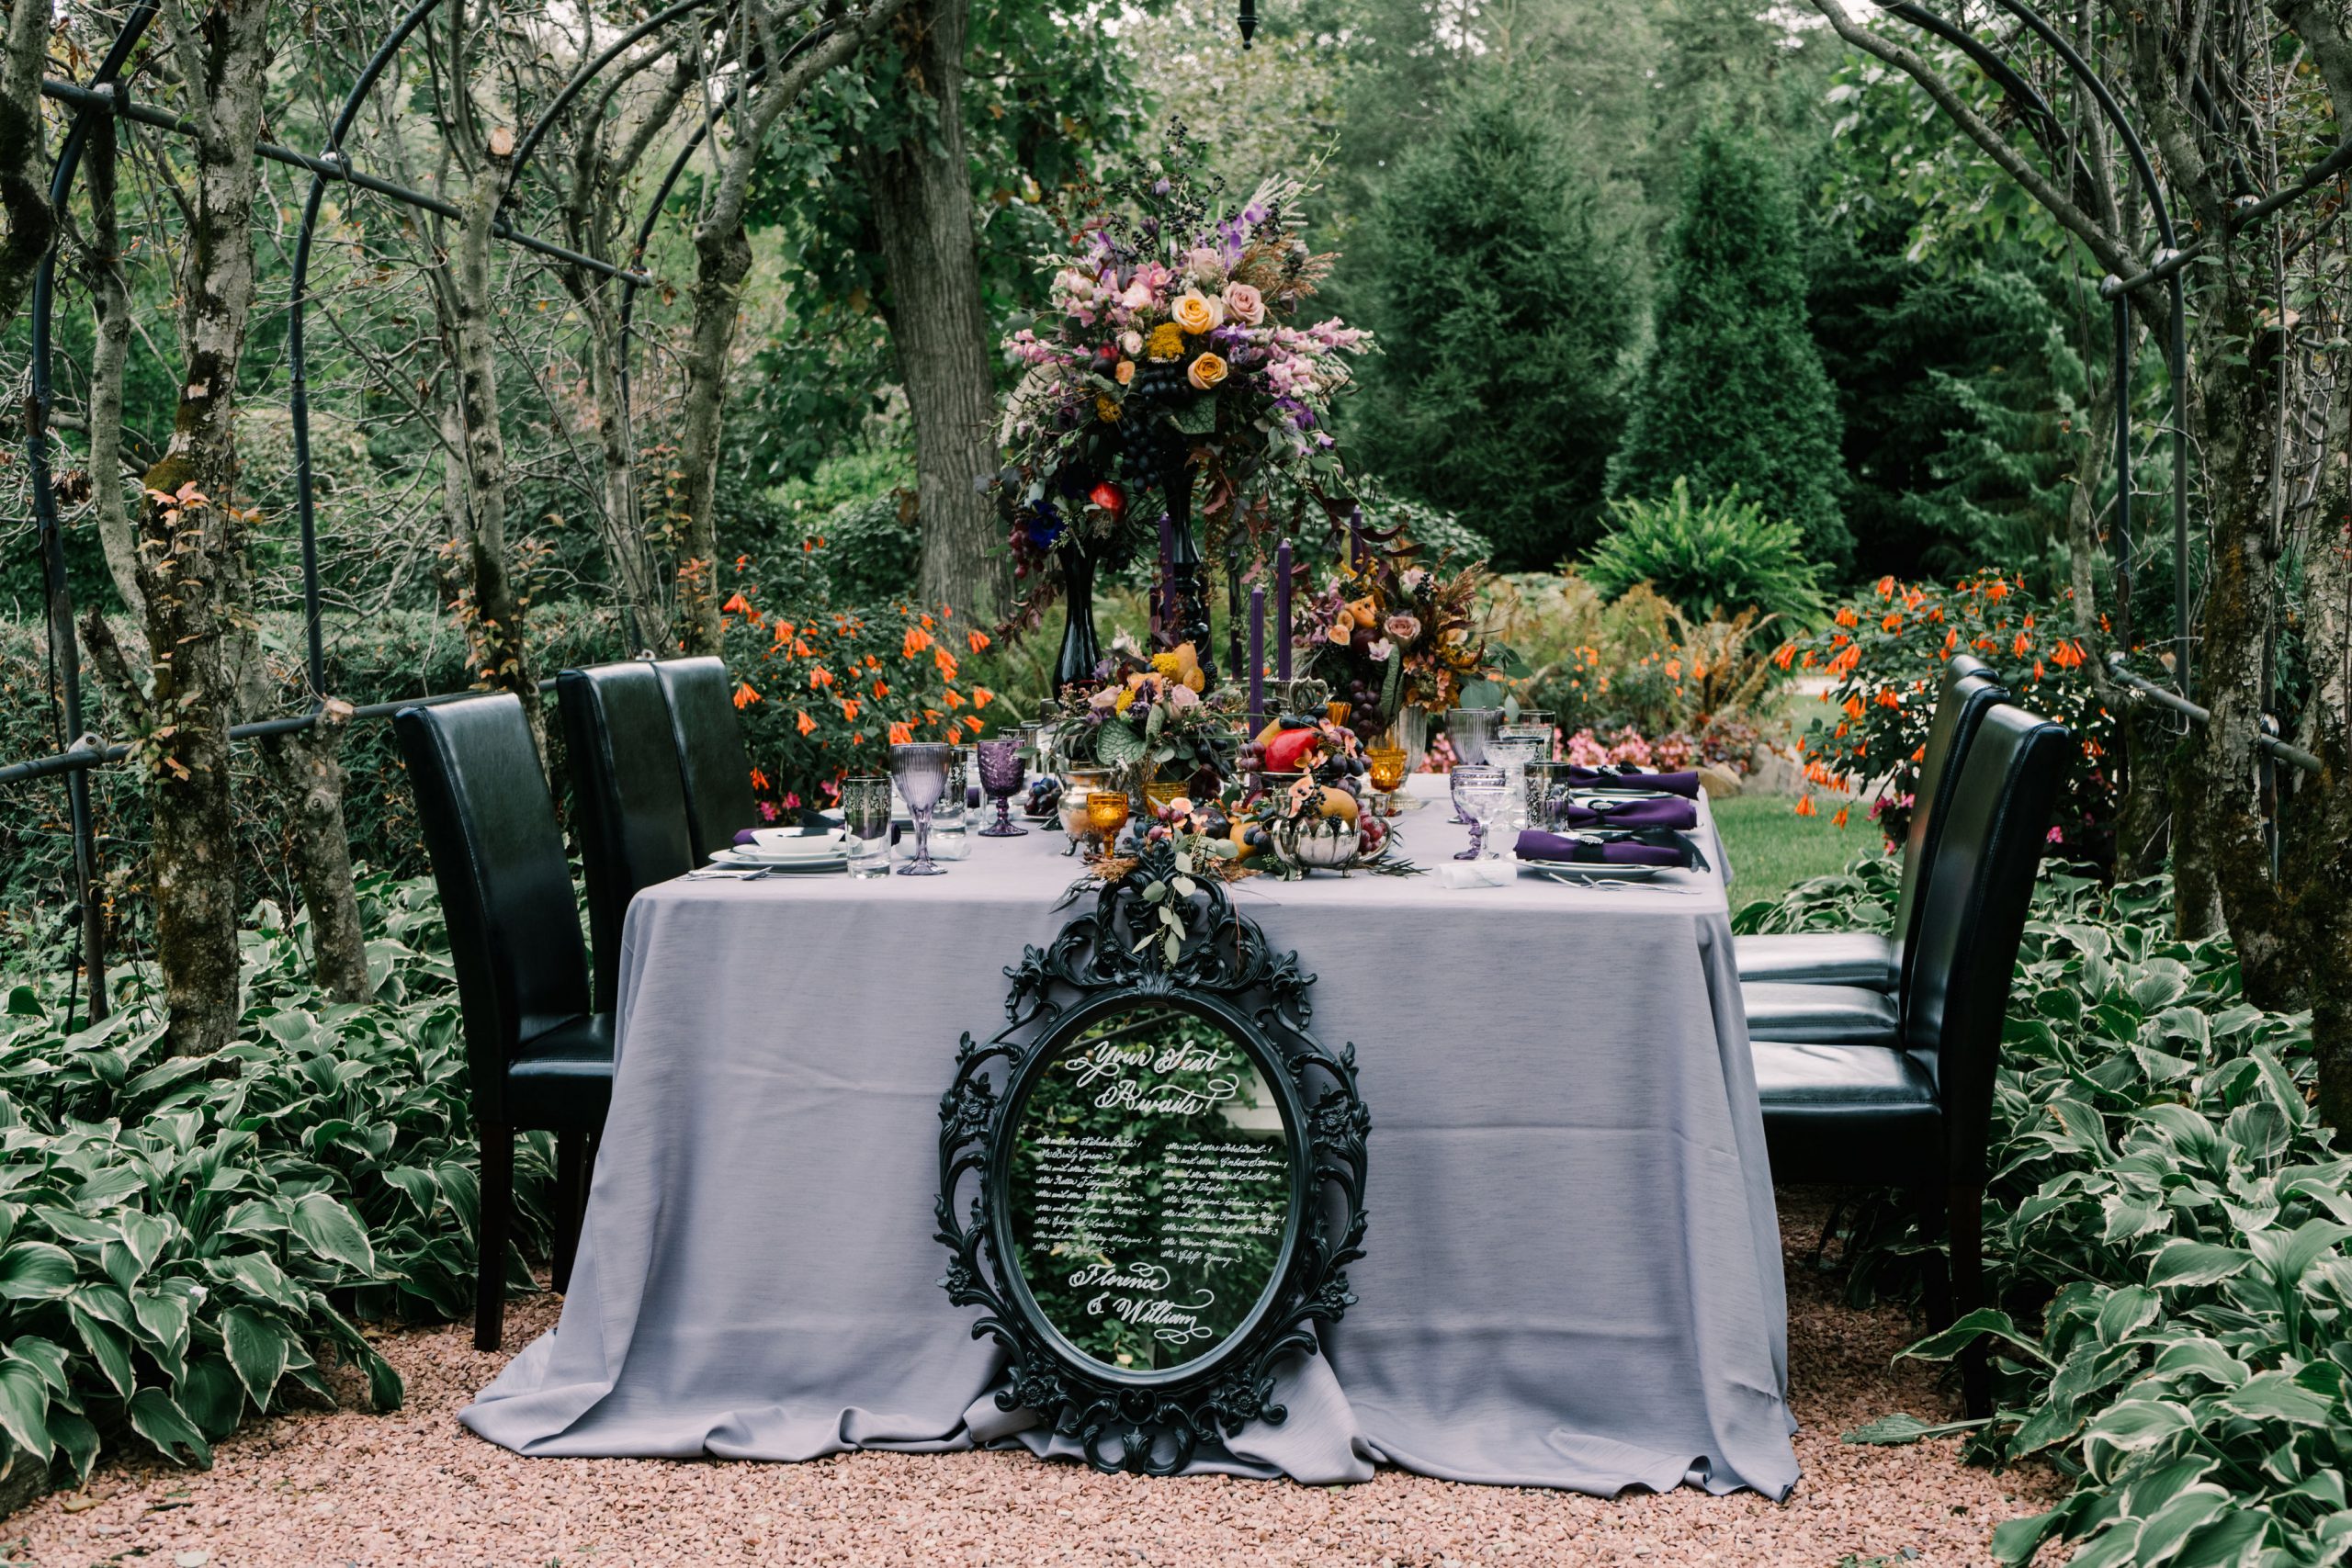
[555,659,694,1013]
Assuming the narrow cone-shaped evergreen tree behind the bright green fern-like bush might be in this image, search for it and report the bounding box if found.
[1609,127,1853,567]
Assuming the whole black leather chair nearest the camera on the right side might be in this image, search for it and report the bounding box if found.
[1750,703,2072,1413]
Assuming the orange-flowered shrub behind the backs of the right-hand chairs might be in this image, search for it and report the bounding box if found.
[1773,571,2121,863]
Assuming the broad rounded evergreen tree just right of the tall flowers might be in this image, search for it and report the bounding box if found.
[1343,73,1639,569]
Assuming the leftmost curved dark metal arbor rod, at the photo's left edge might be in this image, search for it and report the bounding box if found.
[24,0,158,1025]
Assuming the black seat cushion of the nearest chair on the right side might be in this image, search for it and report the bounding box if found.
[1750,1039,1943,1187]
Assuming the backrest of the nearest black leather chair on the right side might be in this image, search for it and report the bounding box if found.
[1903,703,2075,1185]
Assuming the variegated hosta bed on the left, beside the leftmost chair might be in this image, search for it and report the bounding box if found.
[0,874,550,1479]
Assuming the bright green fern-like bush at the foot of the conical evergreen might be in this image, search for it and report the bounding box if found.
[1583,479,1826,626]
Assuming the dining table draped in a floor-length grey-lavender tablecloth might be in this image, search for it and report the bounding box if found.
[461,776,1797,1500]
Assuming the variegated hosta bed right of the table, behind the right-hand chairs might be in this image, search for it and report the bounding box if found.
[1740,863,2352,1565]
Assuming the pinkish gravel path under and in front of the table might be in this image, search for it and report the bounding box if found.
[0,1192,2061,1568]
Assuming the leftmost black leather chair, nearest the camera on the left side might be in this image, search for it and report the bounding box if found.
[393,696,612,1349]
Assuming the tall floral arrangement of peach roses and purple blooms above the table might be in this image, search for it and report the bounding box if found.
[997,127,1371,592]
